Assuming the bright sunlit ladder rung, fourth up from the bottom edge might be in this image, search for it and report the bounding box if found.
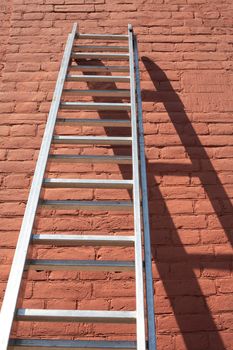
[32,234,134,247]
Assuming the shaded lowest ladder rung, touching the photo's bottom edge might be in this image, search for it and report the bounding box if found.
[8,339,137,350]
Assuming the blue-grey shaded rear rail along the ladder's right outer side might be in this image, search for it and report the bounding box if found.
[134,36,156,350]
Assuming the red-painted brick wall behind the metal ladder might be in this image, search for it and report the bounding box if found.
[0,0,233,350]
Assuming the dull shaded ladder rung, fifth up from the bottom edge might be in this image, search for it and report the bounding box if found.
[39,200,133,211]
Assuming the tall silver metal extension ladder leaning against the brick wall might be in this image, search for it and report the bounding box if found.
[0,24,156,350]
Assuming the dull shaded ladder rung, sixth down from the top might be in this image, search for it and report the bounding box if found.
[63,89,130,97]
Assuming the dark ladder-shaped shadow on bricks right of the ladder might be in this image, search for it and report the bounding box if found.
[142,57,233,350]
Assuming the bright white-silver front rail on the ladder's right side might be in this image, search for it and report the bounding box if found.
[128,25,146,350]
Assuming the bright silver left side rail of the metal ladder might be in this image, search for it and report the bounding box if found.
[0,24,77,350]
